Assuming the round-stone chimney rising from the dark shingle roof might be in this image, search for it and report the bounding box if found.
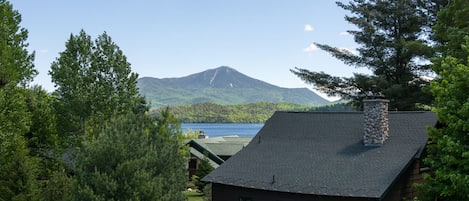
[363,99,389,146]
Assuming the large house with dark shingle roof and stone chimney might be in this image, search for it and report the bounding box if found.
[203,99,437,201]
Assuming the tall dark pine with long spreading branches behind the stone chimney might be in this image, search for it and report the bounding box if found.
[291,0,434,110]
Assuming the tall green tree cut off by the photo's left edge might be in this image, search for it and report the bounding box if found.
[0,0,39,200]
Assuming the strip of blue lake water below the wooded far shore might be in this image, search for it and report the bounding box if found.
[181,123,264,137]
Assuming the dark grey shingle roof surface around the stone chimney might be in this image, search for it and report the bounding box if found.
[203,112,437,198]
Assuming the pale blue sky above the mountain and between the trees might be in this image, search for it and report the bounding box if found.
[10,0,366,99]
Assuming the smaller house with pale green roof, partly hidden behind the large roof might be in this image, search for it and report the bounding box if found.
[186,135,252,179]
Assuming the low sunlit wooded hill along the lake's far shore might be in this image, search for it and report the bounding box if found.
[152,102,352,123]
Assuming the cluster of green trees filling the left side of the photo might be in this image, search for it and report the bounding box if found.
[0,0,189,201]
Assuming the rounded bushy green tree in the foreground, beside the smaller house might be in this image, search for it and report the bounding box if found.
[76,111,186,201]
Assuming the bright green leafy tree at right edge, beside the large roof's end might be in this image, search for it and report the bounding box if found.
[420,36,469,201]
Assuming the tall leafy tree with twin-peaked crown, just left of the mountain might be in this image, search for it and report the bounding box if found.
[49,30,146,143]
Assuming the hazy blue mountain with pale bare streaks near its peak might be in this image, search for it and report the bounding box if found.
[137,66,329,108]
